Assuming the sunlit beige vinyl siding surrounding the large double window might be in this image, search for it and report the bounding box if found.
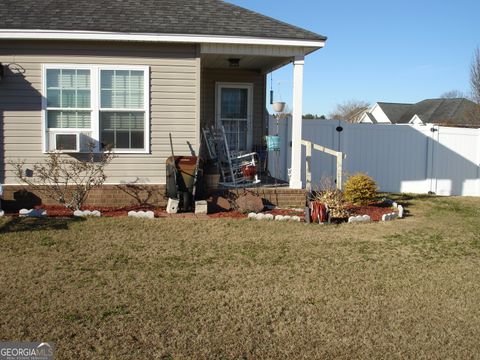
[0,41,200,184]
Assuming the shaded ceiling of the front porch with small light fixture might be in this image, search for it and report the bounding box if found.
[201,54,292,73]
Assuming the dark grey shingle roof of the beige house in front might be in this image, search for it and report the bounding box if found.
[0,0,326,40]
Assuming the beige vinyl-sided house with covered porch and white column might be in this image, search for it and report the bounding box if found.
[0,0,326,207]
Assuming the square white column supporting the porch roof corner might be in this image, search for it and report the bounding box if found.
[290,56,304,189]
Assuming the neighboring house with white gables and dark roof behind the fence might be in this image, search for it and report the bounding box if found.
[359,98,480,127]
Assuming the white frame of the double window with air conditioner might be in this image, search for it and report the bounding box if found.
[42,64,150,154]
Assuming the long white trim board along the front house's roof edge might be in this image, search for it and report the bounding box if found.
[0,29,325,48]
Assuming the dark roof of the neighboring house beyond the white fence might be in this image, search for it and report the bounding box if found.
[398,98,480,126]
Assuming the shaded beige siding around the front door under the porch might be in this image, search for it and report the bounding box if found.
[200,69,266,146]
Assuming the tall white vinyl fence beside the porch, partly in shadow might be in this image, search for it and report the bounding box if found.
[269,118,480,196]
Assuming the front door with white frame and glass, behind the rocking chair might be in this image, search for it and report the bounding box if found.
[216,83,253,151]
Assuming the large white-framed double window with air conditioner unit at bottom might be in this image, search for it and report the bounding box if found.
[43,65,150,153]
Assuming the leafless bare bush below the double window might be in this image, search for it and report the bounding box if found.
[10,146,114,210]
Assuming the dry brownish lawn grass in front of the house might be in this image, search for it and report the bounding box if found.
[0,196,480,359]
